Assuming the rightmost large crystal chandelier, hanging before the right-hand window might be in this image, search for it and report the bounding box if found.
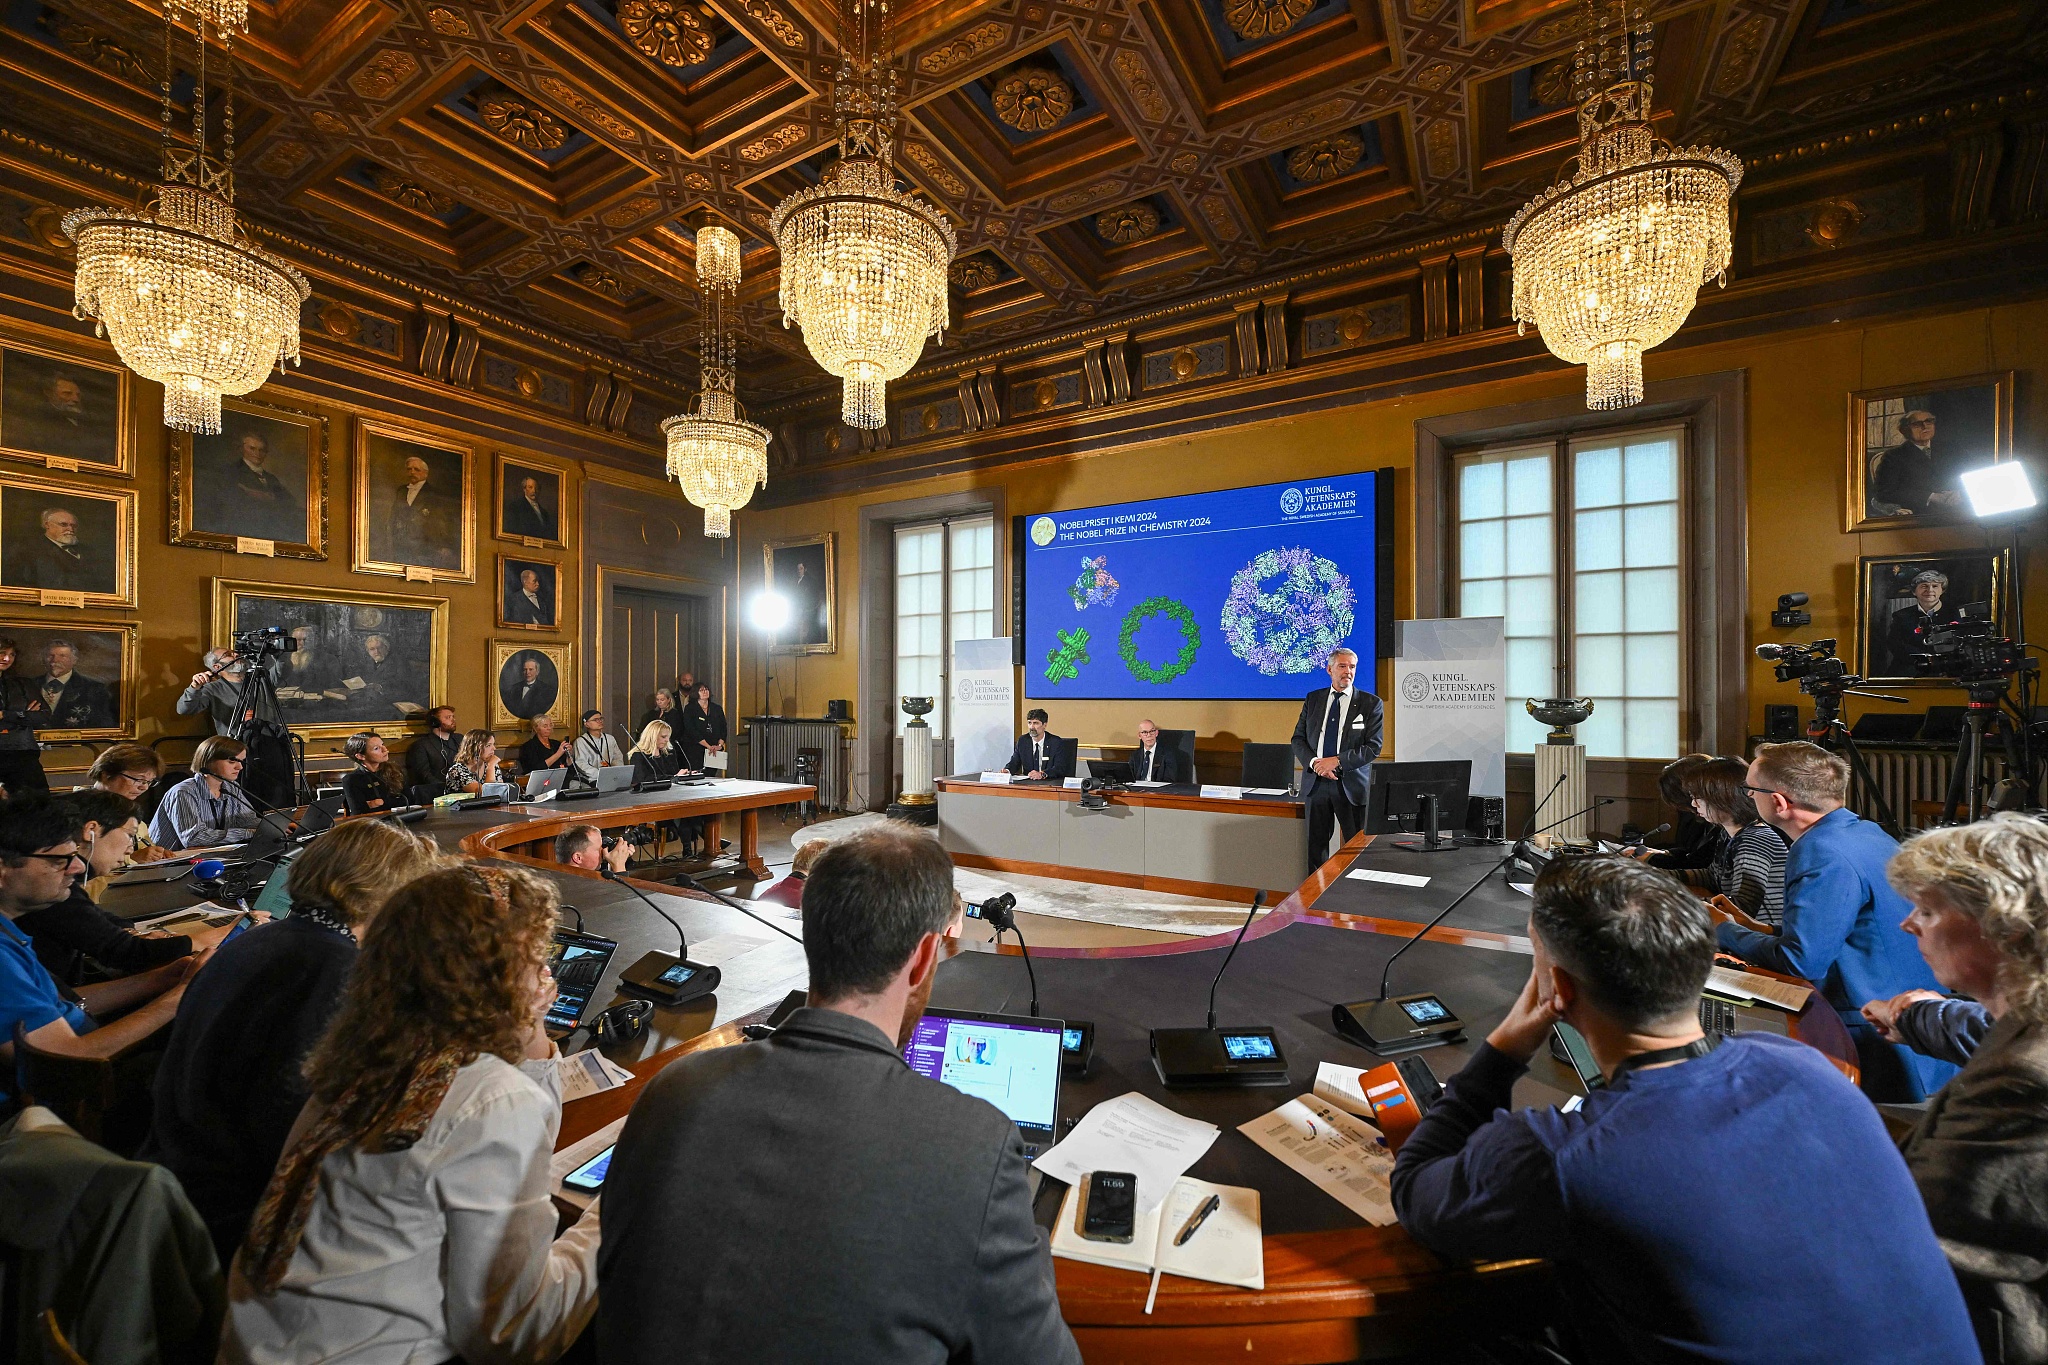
[1501,0,1743,409]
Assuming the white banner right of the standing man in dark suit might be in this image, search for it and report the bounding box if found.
[1393,616,1507,796]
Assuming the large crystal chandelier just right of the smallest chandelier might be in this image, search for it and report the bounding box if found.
[768,0,954,428]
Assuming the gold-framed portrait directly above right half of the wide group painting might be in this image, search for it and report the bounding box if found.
[350,417,477,583]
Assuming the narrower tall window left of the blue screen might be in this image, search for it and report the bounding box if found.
[895,516,995,737]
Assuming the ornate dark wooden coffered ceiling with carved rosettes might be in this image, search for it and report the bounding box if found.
[0,0,2048,435]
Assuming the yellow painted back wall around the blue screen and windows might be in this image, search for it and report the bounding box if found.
[735,301,2048,747]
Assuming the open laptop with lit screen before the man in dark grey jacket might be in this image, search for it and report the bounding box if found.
[903,1009,1067,1160]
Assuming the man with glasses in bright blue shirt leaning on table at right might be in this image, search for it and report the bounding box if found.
[1710,741,1956,1103]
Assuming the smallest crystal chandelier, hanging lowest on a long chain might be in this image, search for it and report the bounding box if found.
[662,225,768,536]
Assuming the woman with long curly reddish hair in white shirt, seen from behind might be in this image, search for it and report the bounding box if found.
[221,868,598,1365]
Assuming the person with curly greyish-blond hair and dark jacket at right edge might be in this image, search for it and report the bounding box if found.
[1864,814,2048,1365]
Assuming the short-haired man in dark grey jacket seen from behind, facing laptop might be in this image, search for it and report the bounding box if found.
[598,823,1081,1365]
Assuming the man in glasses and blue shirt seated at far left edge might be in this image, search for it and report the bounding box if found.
[0,792,211,1105]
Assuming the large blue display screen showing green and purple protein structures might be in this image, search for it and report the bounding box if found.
[1024,473,1380,700]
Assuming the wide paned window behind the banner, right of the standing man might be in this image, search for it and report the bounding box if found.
[1454,430,1683,759]
